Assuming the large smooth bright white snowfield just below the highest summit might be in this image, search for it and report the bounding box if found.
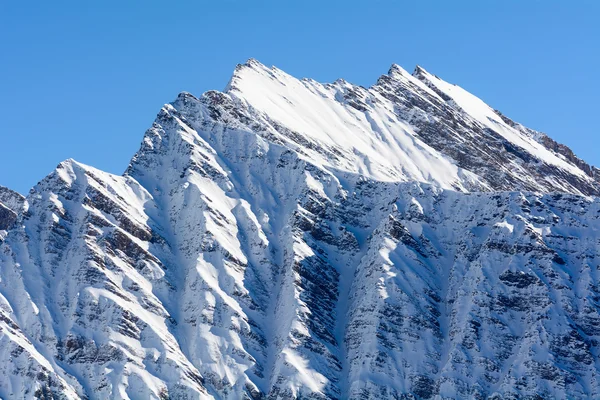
[227,58,482,188]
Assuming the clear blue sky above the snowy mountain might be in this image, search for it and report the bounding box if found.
[0,0,600,193]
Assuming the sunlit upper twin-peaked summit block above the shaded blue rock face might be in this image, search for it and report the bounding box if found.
[218,60,597,194]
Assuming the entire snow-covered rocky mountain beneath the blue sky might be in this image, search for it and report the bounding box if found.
[0,60,600,399]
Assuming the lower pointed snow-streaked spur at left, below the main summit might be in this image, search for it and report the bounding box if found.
[0,160,209,398]
